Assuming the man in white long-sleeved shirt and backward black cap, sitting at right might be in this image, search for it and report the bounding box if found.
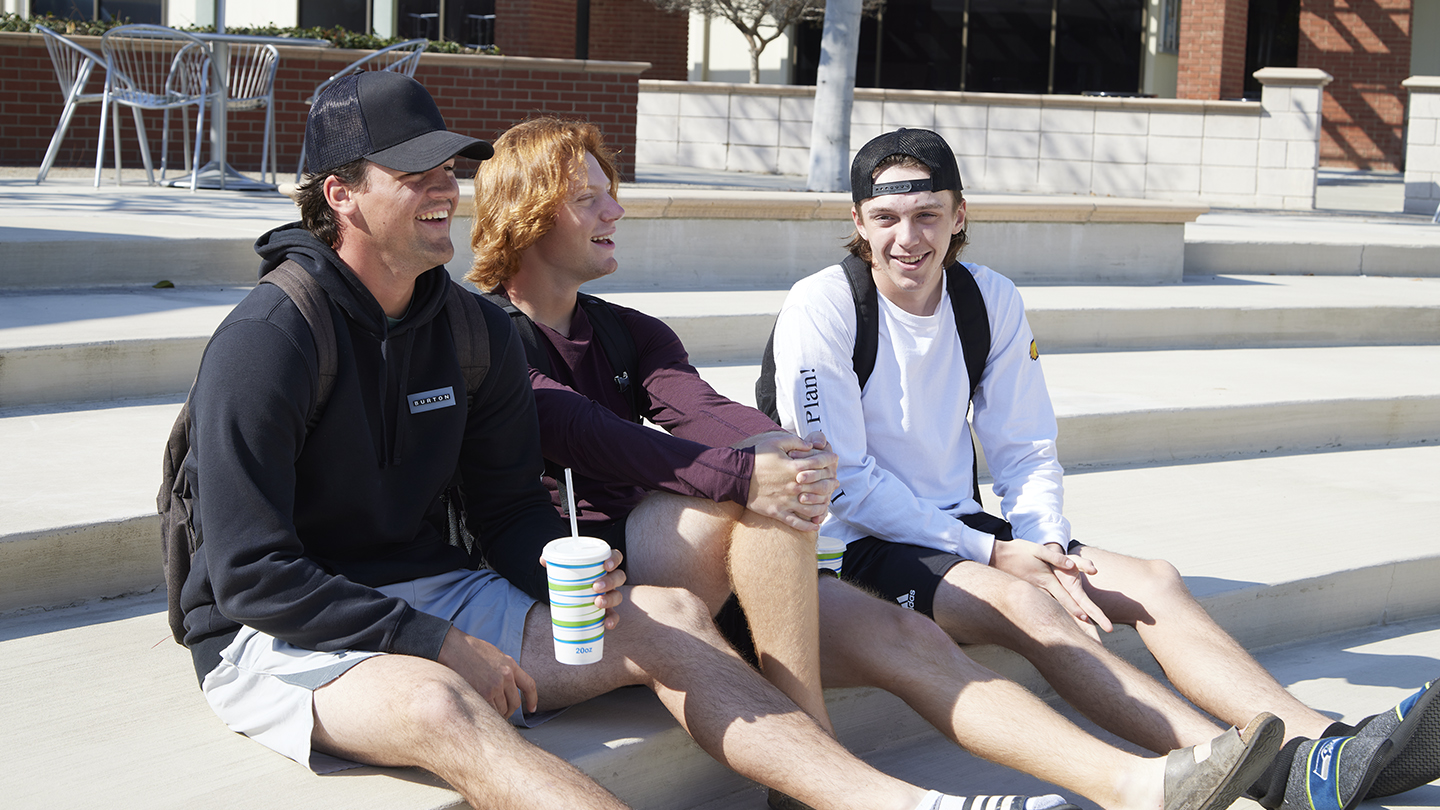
[773,130,1440,810]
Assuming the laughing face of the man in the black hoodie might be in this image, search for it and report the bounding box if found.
[334,160,459,278]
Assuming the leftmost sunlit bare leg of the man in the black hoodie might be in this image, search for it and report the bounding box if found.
[312,656,625,810]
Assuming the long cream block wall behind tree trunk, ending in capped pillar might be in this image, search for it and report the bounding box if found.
[636,68,1329,209]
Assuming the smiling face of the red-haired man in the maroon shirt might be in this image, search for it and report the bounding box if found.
[520,153,625,287]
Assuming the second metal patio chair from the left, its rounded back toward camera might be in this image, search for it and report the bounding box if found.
[95,25,215,192]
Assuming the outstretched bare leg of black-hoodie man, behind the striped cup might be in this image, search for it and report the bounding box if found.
[520,587,924,810]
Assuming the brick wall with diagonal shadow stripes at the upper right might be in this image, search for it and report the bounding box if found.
[1299,0,1411,172]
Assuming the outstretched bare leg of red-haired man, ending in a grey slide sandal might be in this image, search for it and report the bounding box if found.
[819,577,1165,810]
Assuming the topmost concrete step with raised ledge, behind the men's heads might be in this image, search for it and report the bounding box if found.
[0,177,1208,291]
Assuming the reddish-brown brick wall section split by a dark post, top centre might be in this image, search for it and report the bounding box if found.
[495,0,690,81]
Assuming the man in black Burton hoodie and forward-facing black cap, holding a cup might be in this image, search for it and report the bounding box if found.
[181,72,1088,810]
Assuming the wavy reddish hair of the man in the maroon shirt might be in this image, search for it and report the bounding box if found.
[465,117,619,291]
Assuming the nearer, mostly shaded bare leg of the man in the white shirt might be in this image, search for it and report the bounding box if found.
[935,562,1221,754]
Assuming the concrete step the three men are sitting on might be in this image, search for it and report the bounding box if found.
[0,447,1440,810]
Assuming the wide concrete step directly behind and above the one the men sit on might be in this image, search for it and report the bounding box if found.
[0,340,1440,610]
